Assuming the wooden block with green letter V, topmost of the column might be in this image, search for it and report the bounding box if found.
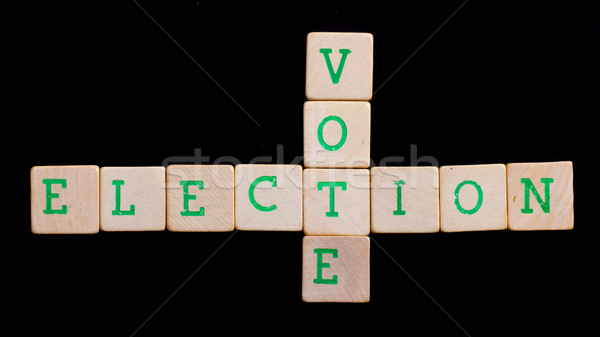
[306,33,373,101]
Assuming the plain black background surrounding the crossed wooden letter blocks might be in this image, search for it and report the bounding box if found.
[0,0,600,336]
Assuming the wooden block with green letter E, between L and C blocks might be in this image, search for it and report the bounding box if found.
[167,165,235,232]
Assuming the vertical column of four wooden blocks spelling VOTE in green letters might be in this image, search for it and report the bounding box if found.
[302,33,373,302]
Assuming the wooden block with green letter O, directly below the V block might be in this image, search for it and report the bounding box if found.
[304,102,371,168]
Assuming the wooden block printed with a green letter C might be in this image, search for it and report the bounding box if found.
[235,164,302,231]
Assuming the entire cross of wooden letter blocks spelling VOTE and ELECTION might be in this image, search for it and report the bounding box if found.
[31,33,574,302]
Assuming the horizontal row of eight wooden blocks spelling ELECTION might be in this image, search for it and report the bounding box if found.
[31,162,573,235]
